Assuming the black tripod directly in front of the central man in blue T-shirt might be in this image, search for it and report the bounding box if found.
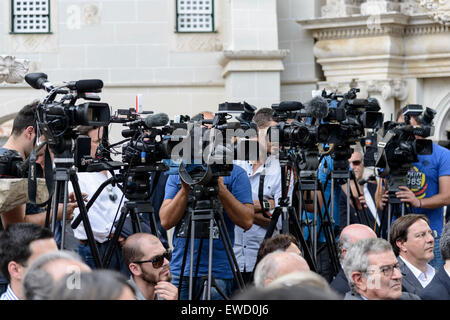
[175,176,245,300]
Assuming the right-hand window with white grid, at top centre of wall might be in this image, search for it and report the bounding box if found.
[176,0,214,32]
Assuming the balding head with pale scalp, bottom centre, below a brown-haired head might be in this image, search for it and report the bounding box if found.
[255,251,310,287]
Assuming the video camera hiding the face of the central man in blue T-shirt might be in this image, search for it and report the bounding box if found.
[169,102,259,185]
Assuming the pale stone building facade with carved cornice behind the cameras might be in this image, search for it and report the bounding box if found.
[0,0,450,144]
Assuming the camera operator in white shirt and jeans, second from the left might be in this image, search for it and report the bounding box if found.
[69,126,129,275]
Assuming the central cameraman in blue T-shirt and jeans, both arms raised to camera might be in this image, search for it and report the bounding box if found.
[159,112,254,300]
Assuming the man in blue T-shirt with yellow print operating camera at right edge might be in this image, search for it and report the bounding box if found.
[396,110,450,269]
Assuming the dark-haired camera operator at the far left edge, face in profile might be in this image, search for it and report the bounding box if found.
[0,100,77,228]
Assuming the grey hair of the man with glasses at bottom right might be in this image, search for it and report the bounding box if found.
[342,238,393,291]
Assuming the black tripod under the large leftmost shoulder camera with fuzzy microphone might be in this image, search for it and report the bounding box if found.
[46,151,102,268]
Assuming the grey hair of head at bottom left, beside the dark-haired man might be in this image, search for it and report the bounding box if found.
[22,250,83,300]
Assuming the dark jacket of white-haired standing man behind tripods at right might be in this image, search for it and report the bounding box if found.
[339,183,387,239]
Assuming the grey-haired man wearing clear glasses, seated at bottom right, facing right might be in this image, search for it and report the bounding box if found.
[343,238,420,300]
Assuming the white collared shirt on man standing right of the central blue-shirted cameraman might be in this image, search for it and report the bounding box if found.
[233,156,293,272]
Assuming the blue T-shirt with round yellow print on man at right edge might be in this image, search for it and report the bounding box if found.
[408,143,450,235]
